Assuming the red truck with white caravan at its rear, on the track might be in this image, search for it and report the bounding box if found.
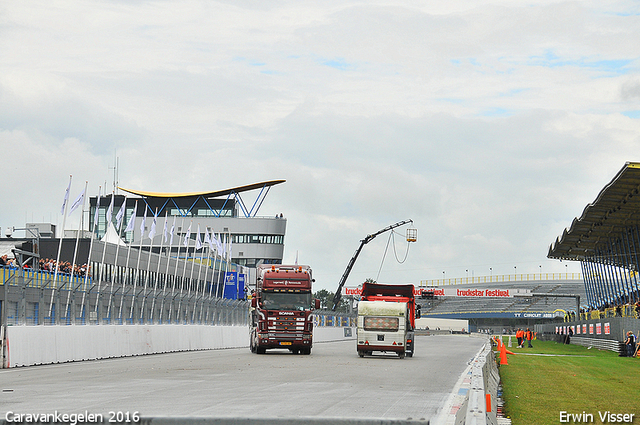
[357,282,415,358]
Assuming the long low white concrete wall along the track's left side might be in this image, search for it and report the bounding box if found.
[0,325,355,368]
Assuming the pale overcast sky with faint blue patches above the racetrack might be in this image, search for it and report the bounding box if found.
[0,0,640,291]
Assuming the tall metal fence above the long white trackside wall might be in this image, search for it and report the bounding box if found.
[0,268,249,325]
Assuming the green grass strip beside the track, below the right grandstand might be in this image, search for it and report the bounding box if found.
[497,338,640,425]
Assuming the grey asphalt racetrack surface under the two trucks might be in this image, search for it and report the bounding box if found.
[0,335,486,423]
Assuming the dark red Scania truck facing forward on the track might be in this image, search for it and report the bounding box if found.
[249,264,320,354]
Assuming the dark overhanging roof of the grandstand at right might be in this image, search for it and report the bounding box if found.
[547,162,640,261]
